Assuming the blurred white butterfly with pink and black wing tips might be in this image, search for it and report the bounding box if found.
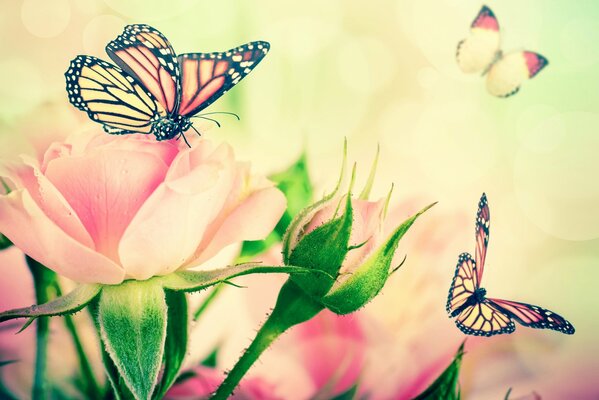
[456,6,548,97]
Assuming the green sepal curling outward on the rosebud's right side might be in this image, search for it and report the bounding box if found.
[322,203,436,314]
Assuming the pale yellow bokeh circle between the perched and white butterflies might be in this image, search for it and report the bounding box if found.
[337,37,397,94]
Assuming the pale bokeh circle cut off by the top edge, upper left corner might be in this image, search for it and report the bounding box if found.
[21,0,71,38]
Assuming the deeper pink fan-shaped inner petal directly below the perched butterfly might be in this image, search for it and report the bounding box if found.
[46,149,167,263]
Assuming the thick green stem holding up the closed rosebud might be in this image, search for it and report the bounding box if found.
[212,280,323,400]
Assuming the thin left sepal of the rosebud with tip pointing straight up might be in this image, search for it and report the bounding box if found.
[283,141,347,265]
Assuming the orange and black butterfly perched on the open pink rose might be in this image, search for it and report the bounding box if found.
[65,25,270,144]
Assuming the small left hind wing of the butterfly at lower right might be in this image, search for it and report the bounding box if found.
[445,253,478,316]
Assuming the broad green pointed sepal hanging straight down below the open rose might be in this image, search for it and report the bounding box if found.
[97,279,167,400]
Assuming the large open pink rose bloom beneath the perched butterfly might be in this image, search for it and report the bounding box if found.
[0,131,285,284]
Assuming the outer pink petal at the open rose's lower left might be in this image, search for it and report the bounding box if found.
[0,189,125,284]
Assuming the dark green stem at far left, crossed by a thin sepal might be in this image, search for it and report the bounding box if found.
[26,256,56,400]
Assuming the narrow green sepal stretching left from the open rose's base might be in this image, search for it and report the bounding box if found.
[0,284,102,322]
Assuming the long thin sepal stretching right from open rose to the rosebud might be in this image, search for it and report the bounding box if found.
[154,264,322,292]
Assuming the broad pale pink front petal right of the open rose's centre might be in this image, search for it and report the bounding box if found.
[119,141,235,279]
